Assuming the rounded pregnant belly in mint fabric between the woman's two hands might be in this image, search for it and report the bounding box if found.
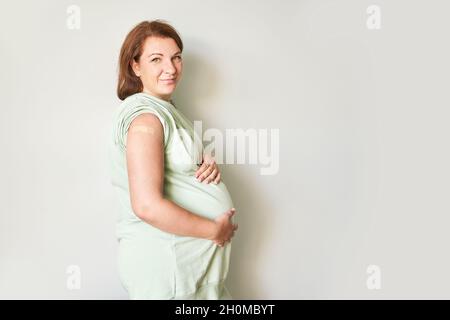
[164,173,234,219]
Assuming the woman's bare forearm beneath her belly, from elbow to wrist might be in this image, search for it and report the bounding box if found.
[140,198,216,240]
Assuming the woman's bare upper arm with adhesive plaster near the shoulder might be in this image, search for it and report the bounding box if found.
[126,113,164,218]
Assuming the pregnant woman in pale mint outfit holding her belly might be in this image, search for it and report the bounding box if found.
[110,20,238,299]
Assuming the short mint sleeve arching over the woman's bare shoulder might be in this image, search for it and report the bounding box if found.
[115,104,170,151]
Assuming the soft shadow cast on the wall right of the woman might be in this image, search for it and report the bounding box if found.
[174,41,272,299]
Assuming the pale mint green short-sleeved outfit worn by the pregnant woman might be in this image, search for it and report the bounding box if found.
[109,93,233,299]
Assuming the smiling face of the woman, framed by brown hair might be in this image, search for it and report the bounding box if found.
[132,37,183,101]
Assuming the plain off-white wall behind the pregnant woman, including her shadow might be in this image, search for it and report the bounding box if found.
[0,0,450,299]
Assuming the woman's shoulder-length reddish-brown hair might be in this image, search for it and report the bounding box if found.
[117,19,183,100]
